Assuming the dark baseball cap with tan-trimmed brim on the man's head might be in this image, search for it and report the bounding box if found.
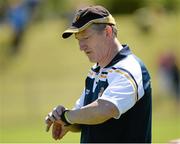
[62,6,116,39]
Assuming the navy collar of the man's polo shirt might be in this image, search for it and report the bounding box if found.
[105,45,132,68]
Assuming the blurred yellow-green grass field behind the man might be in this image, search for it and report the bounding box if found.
[0,15,180,143]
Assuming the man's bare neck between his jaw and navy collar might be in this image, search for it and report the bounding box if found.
[98,38,123,68]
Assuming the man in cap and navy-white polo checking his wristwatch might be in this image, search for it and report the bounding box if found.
[46,6,151,143]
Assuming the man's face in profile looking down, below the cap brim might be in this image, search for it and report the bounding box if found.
[75,28,107,63]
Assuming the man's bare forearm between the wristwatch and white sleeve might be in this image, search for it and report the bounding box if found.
[67,100,118,125]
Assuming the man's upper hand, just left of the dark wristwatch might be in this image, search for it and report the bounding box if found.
[45,105,65,132]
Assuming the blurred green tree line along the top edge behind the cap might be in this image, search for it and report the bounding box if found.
[0,0,180,19]
